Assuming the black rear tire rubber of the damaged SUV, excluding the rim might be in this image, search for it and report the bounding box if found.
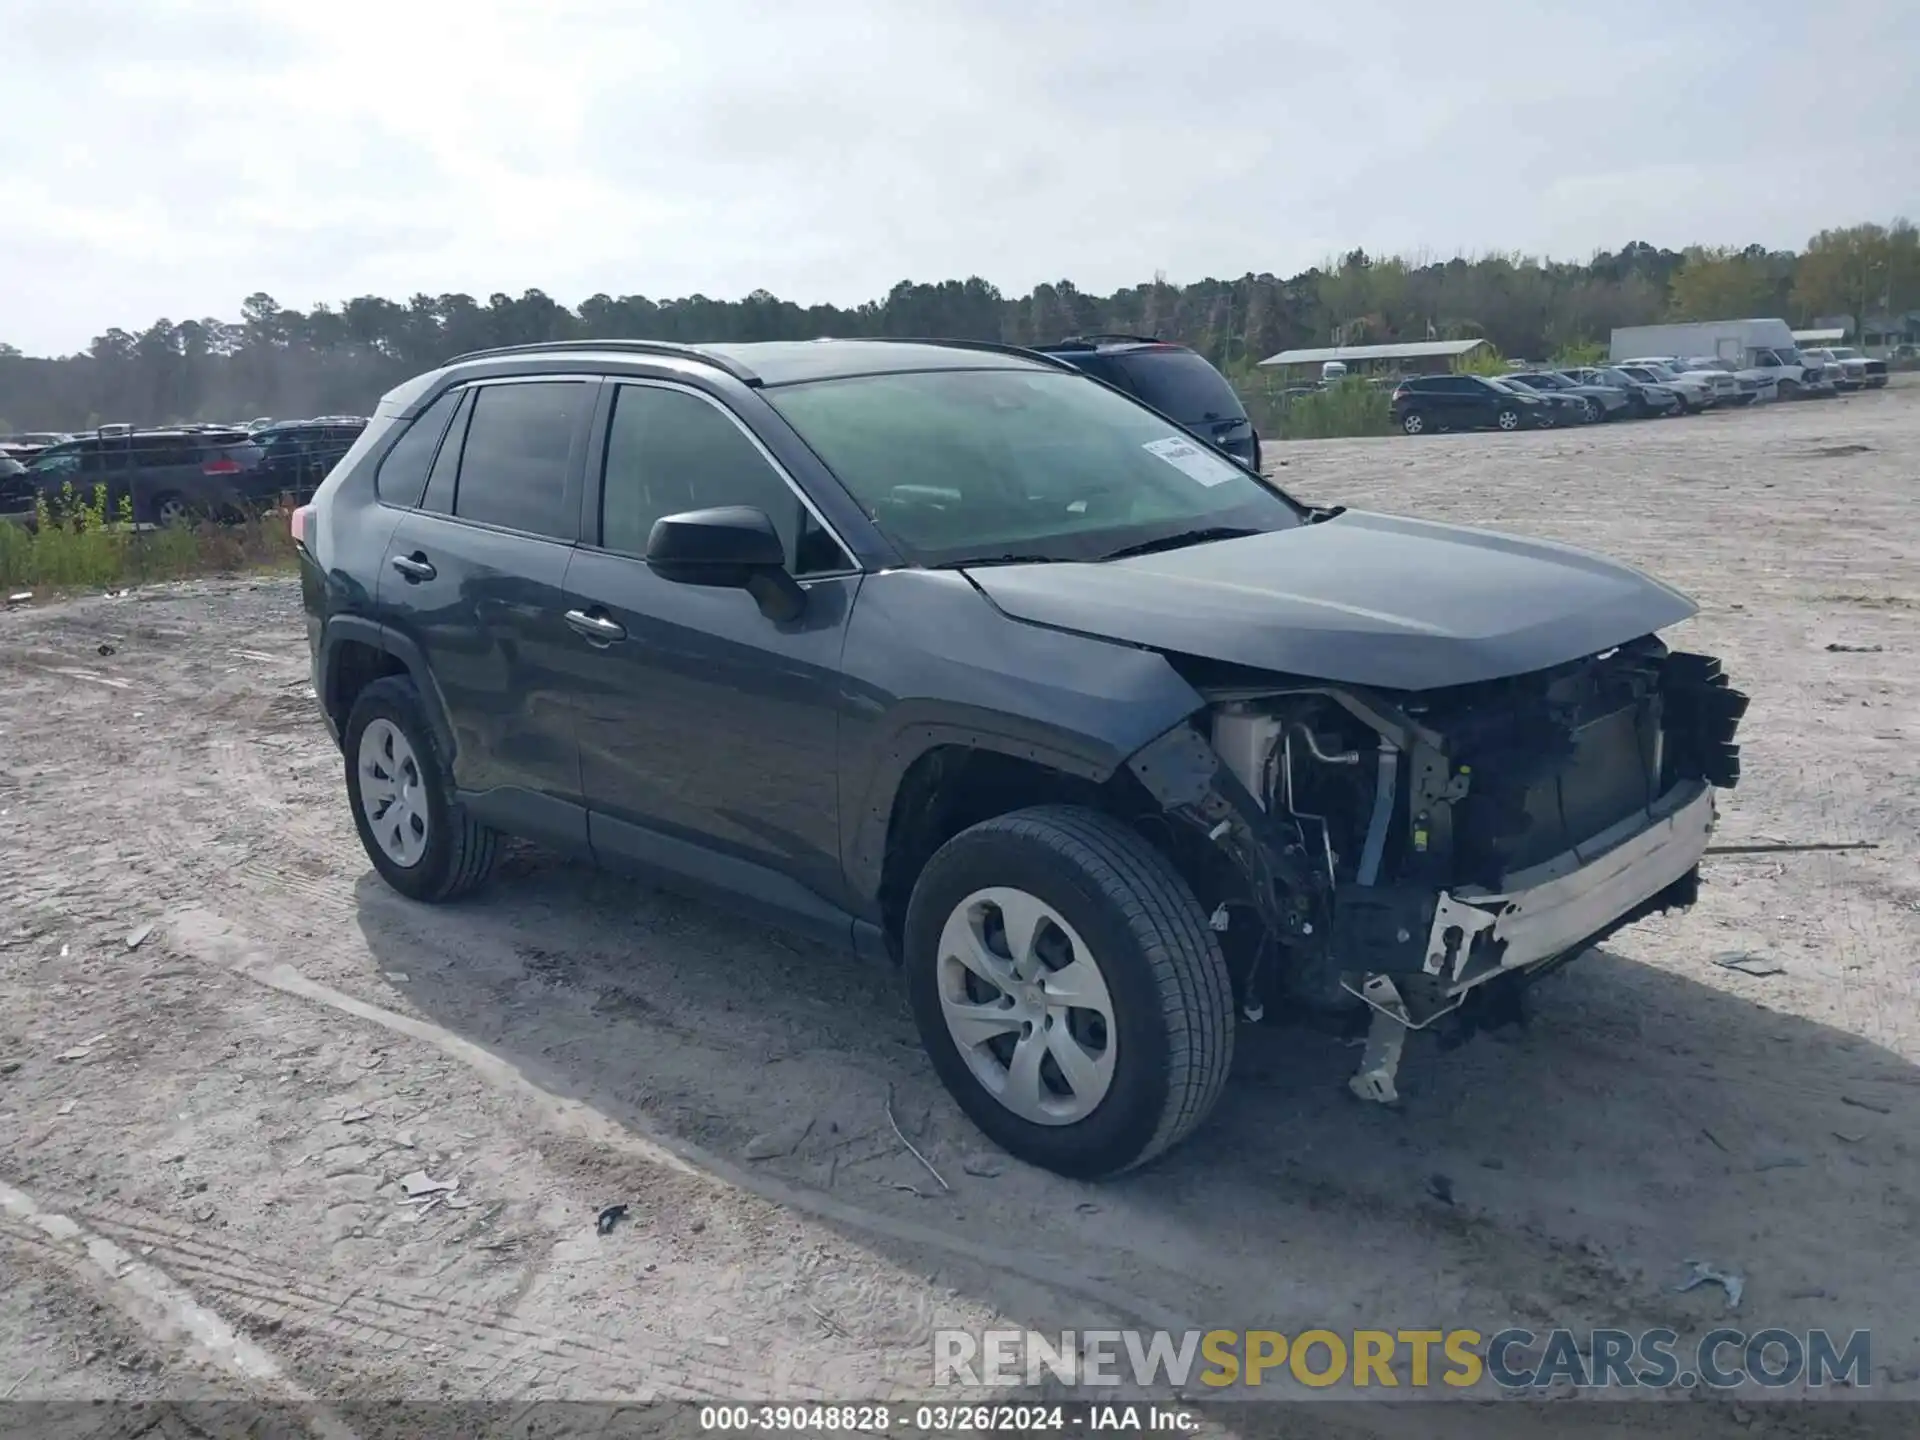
[342,676,499,904]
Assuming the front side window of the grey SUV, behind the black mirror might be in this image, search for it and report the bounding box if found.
[601,386,852,574]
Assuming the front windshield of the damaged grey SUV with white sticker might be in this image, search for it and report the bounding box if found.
[762,371,1306,564]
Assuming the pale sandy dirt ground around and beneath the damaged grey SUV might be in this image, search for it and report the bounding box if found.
[0,384,1920,1436]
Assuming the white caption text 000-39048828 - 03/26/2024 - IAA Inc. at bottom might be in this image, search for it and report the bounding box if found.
[701,1404,1200,1434]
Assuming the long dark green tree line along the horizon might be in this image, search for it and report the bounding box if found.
[0,221,1920,430]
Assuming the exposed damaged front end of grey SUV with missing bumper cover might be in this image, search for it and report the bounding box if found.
[1131,637,1747,1100]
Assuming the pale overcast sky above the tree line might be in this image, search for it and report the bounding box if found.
[0,0,1920,353]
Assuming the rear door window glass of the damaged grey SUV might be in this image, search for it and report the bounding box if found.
[453,380,593,540]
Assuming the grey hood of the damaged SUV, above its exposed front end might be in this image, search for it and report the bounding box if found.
[968,511,1699,691]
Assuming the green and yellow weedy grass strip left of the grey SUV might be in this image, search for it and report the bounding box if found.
[0,486,294,589]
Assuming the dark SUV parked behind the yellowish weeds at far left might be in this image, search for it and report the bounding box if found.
[27,424,259,524]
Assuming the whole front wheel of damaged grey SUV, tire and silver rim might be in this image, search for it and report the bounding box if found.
[902,806,1233,1179]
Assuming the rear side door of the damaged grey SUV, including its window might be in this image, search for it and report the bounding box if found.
[378,376,599,851]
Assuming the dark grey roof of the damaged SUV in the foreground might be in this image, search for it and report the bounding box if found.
[444,338,1071,386]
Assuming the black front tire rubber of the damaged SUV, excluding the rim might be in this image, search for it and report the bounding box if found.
[902,806,1235,1179]
